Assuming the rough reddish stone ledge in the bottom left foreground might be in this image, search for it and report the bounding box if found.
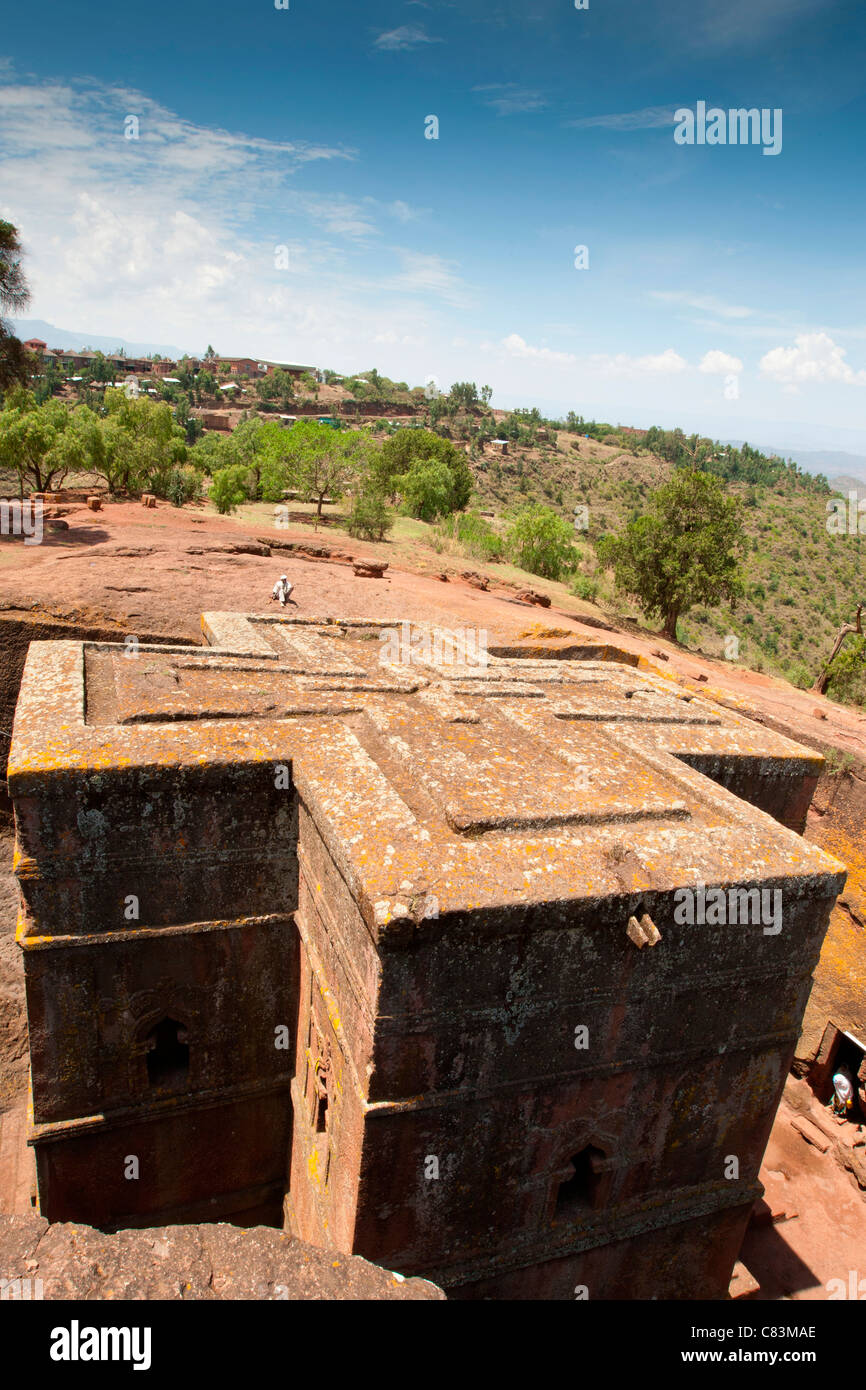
[0,1216,445,1301]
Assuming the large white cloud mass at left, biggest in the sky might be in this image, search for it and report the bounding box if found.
[0,74,480,369]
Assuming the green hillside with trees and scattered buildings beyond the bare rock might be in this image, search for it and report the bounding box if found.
[0,240,866,703]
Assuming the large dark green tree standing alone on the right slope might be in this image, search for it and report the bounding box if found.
[598,468,744,641]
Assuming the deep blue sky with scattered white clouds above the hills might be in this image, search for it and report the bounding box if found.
[0,0,866,450]
